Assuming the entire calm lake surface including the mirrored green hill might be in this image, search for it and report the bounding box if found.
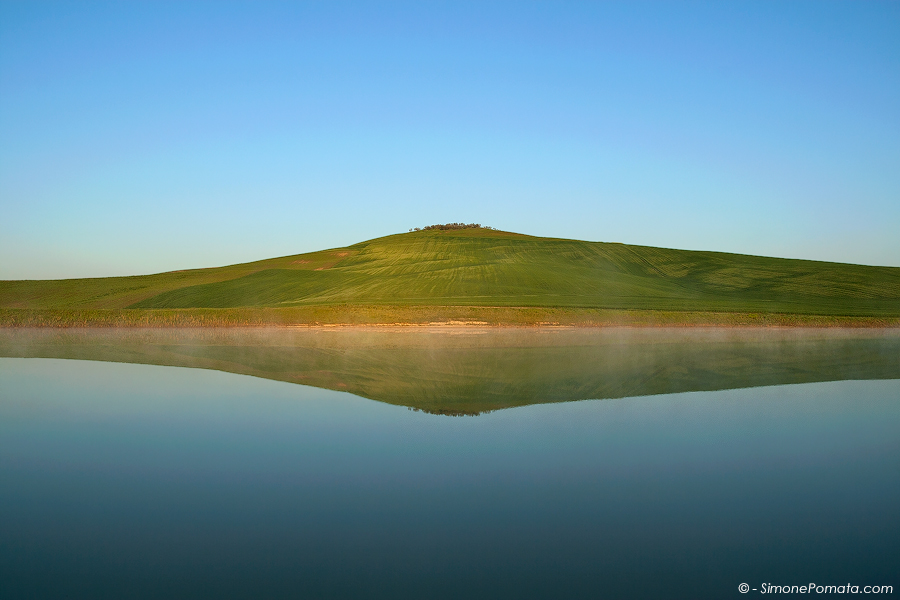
[0,328,900,598]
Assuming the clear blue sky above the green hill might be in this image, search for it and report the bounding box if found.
[0,0,900,279]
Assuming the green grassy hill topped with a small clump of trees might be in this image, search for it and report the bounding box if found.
[0,229,900,317]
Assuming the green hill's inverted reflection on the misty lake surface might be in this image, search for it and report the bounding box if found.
[0,329,900,414]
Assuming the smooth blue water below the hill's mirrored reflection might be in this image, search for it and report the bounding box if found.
[0,358,900,598]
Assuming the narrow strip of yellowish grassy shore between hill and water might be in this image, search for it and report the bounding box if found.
[0,306,900,330]
